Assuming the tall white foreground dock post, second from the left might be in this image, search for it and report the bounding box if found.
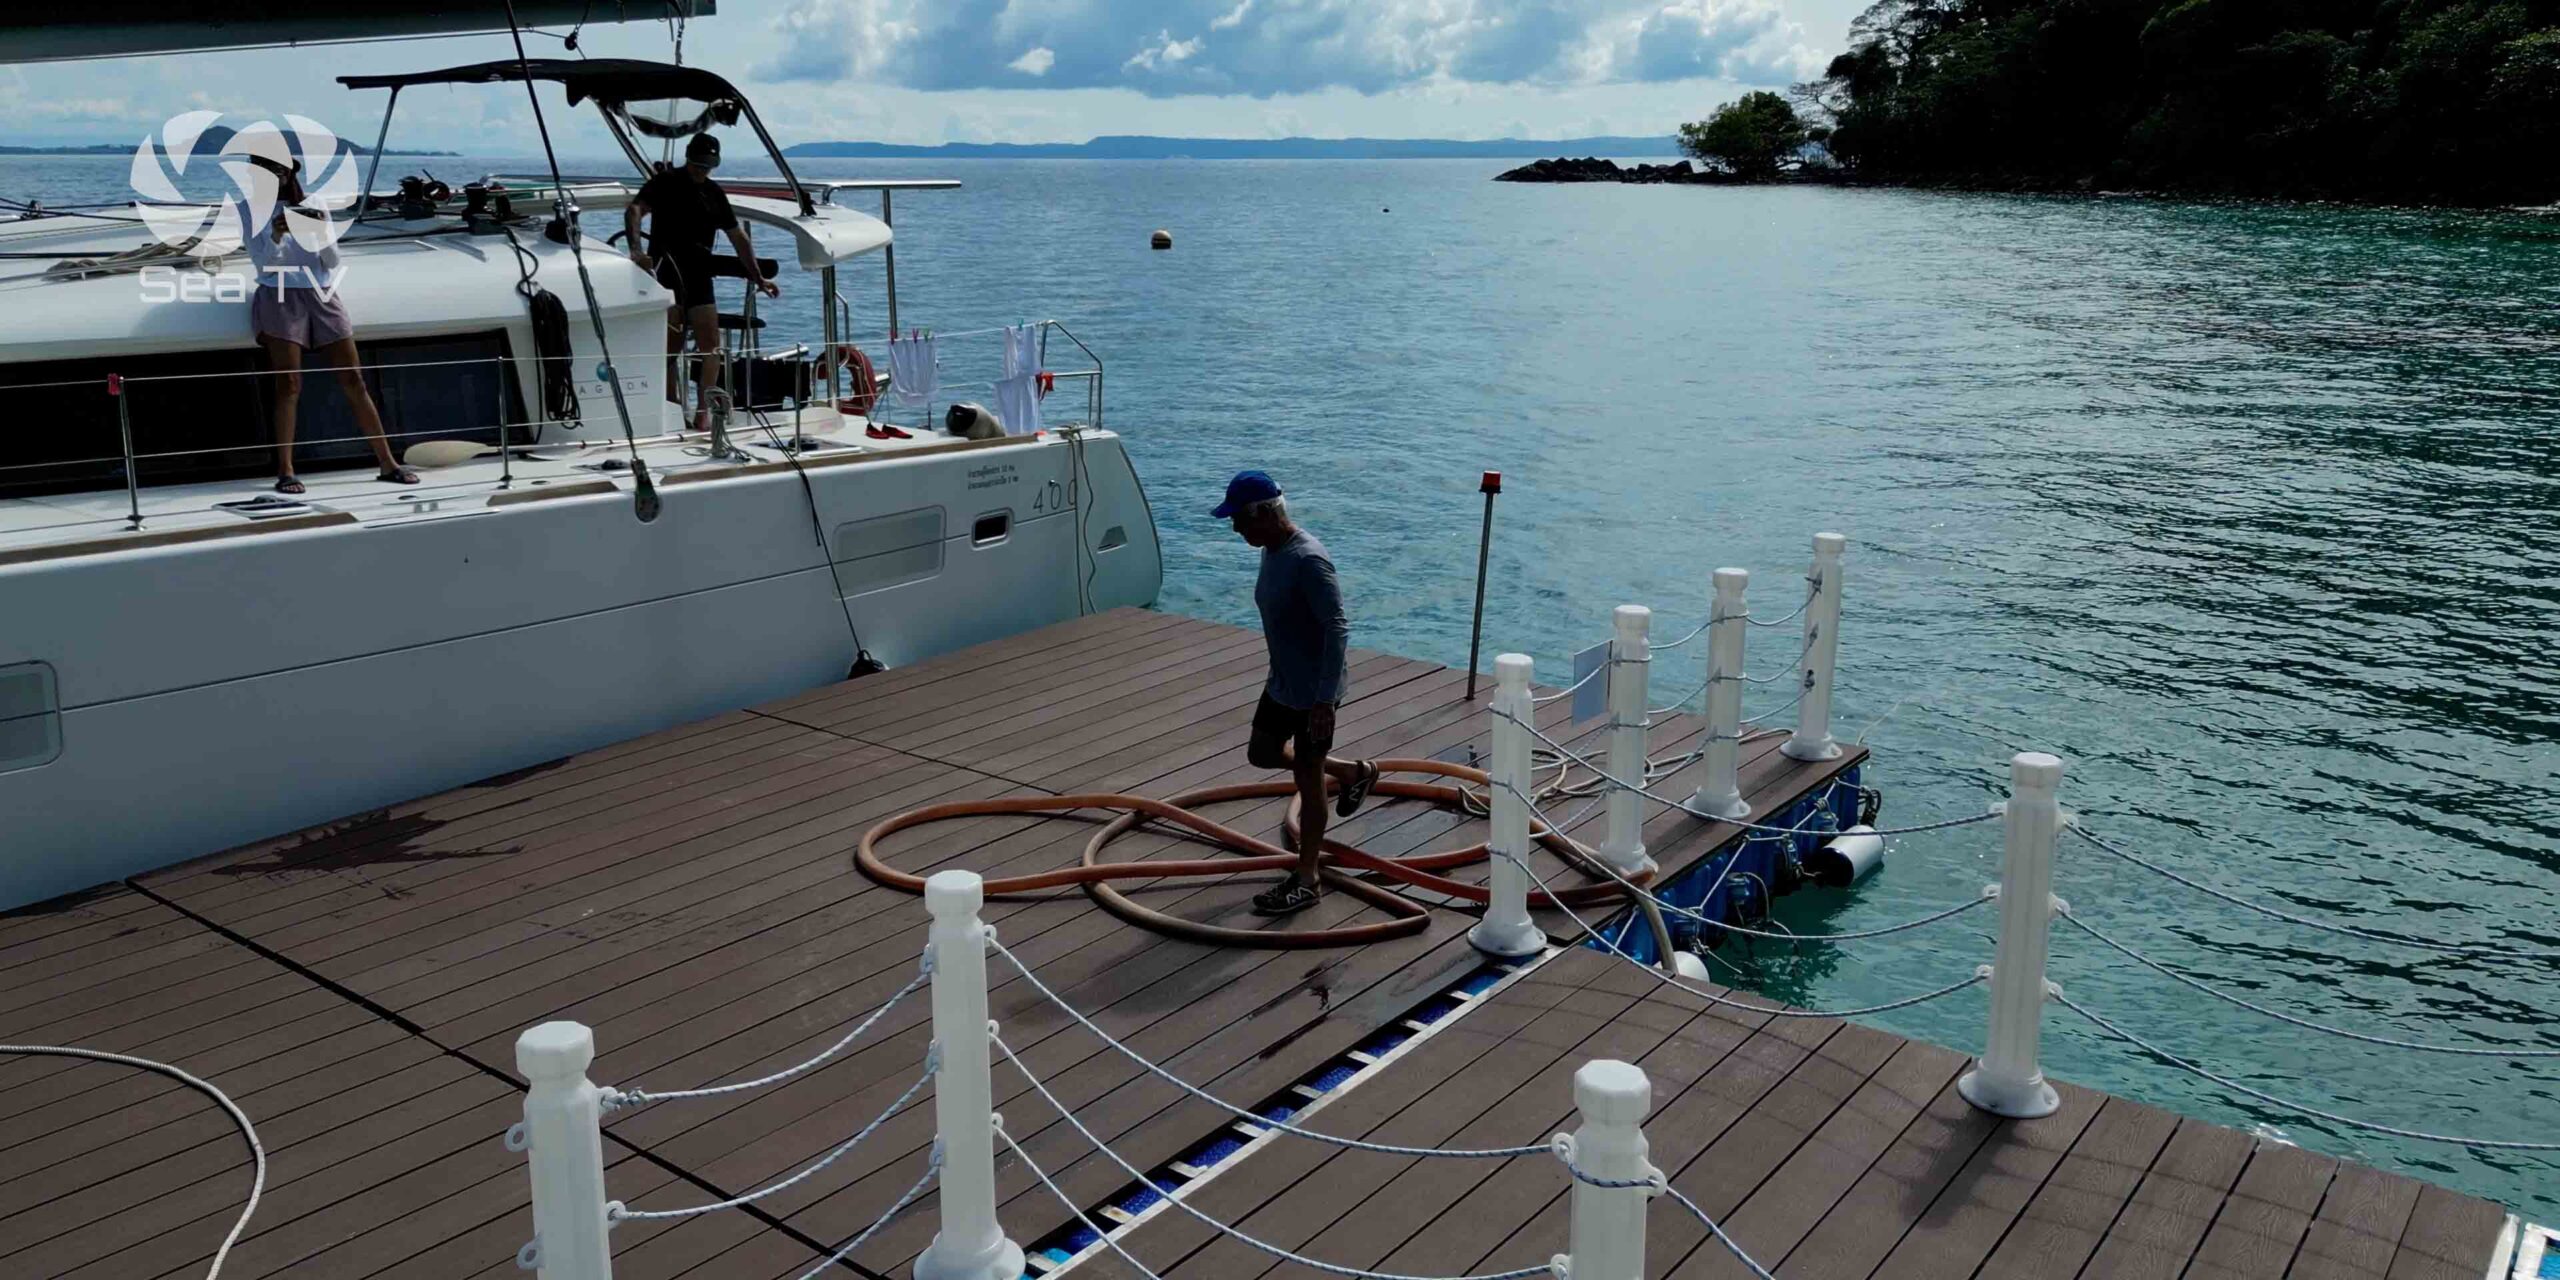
[916,870,1021,1280]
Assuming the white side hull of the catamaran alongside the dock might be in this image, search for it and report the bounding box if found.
[0,433,1162,906]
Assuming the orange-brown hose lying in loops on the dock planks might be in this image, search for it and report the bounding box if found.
[855,758,1651,947]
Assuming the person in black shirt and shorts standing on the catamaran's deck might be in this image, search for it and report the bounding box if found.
[622,133,783,430]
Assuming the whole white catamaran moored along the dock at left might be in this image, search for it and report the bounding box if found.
[0,0,1162,906]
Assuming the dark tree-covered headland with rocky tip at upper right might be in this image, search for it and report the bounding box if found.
[1679,0,2560,205]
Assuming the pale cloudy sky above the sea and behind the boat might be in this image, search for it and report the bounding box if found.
[0,0,1869,154]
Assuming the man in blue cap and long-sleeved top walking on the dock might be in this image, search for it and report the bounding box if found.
[1208,471,1377,916]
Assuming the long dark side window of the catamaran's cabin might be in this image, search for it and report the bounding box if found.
[0,330,532,497]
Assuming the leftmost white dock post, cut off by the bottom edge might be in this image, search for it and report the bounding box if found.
[515,1021,614,1280]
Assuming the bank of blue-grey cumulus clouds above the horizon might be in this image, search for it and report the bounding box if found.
[758,0,1820,97]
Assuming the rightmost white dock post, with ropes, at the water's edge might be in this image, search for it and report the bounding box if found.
[1956,750,2063,1119]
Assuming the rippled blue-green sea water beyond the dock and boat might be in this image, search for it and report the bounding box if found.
[0,159,2560,1219]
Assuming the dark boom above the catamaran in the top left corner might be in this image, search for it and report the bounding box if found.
[0,0,717,64]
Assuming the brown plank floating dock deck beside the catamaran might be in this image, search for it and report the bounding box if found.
[0,609,2504,1280]
